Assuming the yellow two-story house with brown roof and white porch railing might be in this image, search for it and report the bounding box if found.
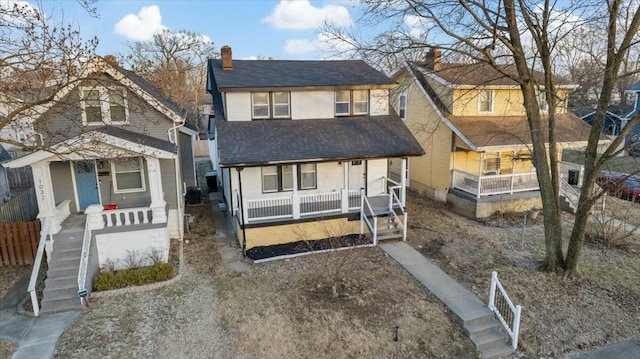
[390,49,590,218]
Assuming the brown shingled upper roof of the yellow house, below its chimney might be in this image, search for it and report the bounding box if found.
[412,62,577,88]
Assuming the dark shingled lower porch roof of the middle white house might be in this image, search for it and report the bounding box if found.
[216,115,424,167]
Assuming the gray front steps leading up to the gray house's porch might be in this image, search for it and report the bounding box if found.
[40,231,84,314]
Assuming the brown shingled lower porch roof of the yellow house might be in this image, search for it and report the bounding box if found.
[447,114,607,150]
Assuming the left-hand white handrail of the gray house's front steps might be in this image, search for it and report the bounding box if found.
[27,201,71,317]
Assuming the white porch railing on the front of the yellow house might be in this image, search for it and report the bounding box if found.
[453,170,540,197]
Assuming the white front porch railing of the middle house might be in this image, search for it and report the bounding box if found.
[245,189,361,223]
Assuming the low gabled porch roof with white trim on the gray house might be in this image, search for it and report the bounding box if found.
[3,126,176,168]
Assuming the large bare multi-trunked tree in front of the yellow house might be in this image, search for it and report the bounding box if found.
[328,0,640,276]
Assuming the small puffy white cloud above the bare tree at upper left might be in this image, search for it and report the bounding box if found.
[113,5,165,41]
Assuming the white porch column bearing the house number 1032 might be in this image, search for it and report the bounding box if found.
[31,161,61,234]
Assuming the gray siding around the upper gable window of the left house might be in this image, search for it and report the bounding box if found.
[35,76,173,146]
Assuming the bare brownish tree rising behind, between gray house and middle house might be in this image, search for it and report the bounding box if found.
[121,29,218,118]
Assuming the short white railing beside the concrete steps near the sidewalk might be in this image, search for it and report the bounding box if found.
[489,271,522,349]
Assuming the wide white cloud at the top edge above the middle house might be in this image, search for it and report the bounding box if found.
[262,0,353,30]
